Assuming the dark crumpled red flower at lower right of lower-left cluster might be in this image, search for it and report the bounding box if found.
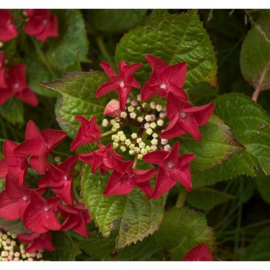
[58,204,91,237]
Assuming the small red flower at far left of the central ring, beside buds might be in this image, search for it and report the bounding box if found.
[70,115,100,152]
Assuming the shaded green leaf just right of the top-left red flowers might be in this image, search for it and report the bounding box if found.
[46,9,89,71]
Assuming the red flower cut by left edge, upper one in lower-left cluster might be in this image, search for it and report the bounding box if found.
[0,141,28,185]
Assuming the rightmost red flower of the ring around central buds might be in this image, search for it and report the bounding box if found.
[160,93,215,141]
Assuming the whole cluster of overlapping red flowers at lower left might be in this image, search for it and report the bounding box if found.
[0,121,91,252]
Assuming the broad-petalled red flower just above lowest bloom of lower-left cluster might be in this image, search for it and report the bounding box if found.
[23,191,61,233]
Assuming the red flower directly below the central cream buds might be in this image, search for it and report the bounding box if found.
[103,159,156,198]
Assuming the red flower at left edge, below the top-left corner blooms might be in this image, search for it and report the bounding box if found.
[0,64,38,106]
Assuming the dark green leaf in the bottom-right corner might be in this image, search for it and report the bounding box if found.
[242,228,270,261]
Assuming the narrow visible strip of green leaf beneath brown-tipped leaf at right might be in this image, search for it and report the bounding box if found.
[192,151,258,187]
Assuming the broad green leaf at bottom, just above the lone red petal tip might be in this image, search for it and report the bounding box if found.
[154,207,214,261]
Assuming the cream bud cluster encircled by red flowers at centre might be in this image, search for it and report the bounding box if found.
[102,95,171,159]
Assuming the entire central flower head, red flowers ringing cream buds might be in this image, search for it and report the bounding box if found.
[71,55,215,199]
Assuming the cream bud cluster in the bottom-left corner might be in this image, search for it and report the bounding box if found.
[0,230,43,261]
